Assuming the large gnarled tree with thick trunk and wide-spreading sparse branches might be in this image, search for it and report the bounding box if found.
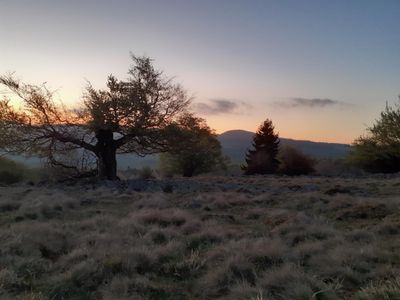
[0,55,190,180]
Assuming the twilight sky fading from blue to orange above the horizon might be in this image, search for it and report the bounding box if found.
[0,0,400,143]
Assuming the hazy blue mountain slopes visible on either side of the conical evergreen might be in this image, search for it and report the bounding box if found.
[218,130,350,163]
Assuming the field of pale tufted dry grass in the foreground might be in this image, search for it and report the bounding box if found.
[0,176,400,300]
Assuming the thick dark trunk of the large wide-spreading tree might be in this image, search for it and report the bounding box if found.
[96,130,118,180]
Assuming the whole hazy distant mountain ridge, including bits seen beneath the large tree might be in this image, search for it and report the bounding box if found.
[3,130,349,169]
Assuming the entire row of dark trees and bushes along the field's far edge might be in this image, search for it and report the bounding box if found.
[0,55,400,180]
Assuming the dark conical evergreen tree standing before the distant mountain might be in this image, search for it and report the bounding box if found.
[242,119,279,175]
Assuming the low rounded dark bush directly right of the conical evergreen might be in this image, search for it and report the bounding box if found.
[278,146,315,176]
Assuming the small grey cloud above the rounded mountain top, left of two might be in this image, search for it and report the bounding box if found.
[192,99,251,115]
